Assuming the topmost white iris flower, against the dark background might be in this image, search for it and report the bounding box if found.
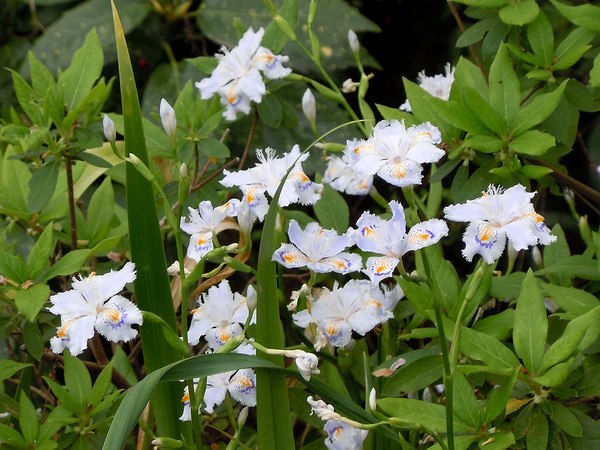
[196,28,291,120]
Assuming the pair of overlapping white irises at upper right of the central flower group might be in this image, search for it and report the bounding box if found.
[323,120,445,195]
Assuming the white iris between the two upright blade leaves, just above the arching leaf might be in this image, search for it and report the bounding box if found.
[188,280,254,350]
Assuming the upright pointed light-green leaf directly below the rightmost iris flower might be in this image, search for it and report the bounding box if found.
[513,270,548,375]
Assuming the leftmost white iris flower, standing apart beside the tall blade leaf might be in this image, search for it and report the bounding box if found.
[48,262,143,356]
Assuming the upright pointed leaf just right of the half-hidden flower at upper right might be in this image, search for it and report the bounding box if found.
[489,45,521,124]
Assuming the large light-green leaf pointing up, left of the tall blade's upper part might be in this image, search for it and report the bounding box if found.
[58,28,104,110]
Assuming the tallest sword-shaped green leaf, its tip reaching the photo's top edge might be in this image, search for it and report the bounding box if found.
[110,2,183,440]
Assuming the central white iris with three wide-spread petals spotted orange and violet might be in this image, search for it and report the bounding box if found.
[352,201,448,283]
